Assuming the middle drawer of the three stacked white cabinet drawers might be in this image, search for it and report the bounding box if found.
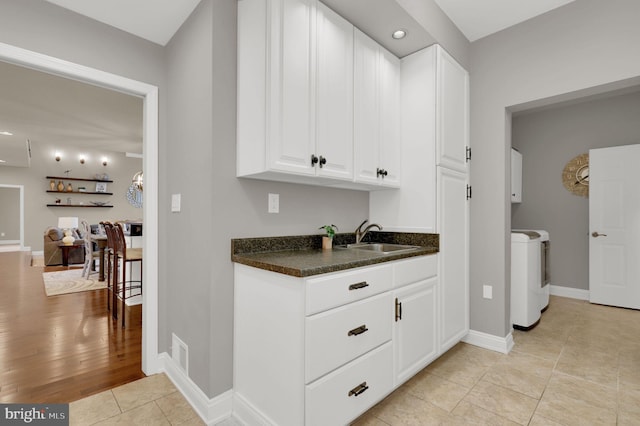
[305,293,394,383]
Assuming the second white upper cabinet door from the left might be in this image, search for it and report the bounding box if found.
[316,2,353,180]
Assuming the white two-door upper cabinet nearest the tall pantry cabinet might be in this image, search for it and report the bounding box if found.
[354,29,400,187]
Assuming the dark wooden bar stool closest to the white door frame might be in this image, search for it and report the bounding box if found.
[112,223,142,328]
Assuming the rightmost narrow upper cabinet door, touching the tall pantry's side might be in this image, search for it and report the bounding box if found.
[378,48,402,187]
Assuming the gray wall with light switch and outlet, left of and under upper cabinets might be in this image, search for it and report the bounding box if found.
[166,0,369,396]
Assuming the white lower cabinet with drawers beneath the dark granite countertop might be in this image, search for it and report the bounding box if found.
[234,255,452,426]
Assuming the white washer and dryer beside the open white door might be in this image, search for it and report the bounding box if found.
[511,229,550,330]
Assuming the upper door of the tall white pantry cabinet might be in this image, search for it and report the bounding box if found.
[436,46,469,172]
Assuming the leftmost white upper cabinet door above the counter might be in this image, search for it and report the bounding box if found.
[267,0,316,174]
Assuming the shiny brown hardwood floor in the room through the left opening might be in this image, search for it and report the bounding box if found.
[0,252,145,403]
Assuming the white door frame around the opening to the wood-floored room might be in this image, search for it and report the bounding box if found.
[0,43,160,375]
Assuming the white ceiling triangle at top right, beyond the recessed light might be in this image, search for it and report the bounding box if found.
[434,0,574,42]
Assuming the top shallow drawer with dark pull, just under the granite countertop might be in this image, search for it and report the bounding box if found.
[306,265,393,315]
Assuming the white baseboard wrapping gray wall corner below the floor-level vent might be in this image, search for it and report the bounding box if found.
[158,352,233,425]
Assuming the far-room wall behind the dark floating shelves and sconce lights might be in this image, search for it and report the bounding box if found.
[0,141,142,251]
